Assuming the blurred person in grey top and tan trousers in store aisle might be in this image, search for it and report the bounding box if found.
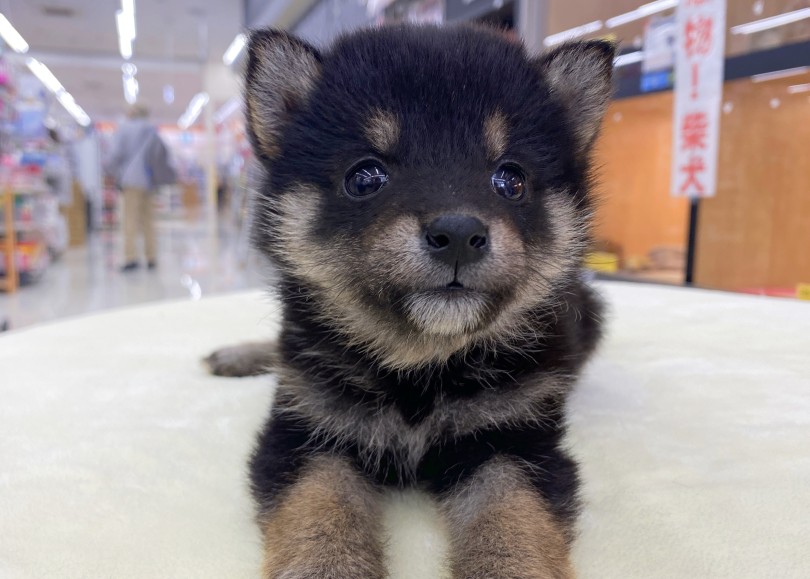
[106,105,176,272]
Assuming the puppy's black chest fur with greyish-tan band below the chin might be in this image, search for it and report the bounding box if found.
[275,322,576,487]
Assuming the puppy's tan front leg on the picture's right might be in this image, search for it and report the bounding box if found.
[443,457,574,579]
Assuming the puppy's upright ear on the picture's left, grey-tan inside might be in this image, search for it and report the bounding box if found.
[245,29,321,159]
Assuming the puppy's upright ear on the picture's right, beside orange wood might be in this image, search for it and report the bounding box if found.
[537,40,616,153]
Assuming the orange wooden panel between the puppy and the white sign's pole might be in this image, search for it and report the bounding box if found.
[595,93,689,264]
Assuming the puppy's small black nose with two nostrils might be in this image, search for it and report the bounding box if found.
[425,215,489,267]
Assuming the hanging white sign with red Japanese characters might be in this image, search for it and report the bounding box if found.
[671,0,726,197]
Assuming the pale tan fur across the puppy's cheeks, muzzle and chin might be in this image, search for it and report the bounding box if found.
[265,184,588,367]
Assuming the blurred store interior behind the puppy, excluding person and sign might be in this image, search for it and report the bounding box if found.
[0,0,810,329]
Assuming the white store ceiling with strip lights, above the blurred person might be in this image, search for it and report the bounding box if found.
[0,0,243,122]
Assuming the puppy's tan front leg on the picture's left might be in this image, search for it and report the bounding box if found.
[259,456,386,579]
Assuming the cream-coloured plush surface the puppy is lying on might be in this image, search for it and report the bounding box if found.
[0,284,810,579]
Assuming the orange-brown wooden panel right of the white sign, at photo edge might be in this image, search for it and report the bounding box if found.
[695,75,810,290]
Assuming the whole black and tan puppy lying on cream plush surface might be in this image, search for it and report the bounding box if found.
[211,26,614,579]
